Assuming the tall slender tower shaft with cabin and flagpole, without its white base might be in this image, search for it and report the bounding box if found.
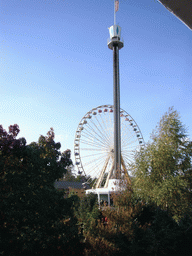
[107,0,123,179]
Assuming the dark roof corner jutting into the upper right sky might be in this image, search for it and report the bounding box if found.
[158,0,192,29]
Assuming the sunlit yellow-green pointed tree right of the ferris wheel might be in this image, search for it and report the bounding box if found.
[133,108,192,219]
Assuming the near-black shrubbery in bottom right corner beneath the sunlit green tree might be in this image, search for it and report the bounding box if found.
[130,204,192,256]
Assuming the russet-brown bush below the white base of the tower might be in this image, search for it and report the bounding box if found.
[80,188,138,256]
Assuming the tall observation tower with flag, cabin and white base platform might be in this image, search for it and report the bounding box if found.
[86,0,124,205]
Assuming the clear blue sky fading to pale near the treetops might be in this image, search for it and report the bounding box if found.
[0,0,192,172]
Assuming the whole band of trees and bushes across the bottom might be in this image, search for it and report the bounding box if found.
[0,108,192,256]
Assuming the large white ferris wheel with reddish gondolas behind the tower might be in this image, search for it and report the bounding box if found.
[74,105,144,187]
